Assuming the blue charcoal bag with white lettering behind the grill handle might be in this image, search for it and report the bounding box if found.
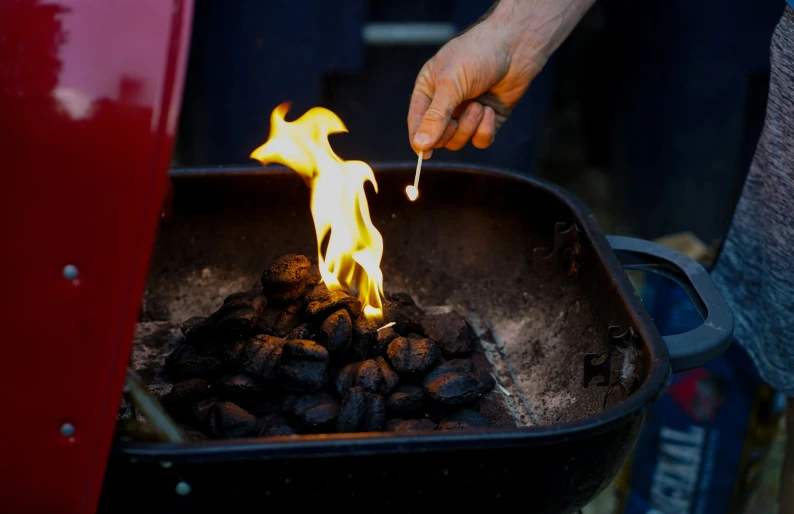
[617,275,785,514]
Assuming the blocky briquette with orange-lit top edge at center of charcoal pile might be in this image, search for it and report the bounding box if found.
[278,339,328,392]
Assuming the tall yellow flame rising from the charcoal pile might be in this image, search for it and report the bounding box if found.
[251,103,383,319]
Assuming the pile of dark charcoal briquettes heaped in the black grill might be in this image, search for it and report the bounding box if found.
[162,255,504,439]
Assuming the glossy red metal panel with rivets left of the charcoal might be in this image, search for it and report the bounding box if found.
[0,0,193,513]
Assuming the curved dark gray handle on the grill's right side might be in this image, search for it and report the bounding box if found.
[607,236,733,373]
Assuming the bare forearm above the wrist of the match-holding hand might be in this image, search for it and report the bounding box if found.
[483,0,595,63]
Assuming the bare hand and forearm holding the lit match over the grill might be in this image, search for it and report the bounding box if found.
[408,0,594,159]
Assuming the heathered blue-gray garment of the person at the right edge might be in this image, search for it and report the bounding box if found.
[713,7,794,396]
